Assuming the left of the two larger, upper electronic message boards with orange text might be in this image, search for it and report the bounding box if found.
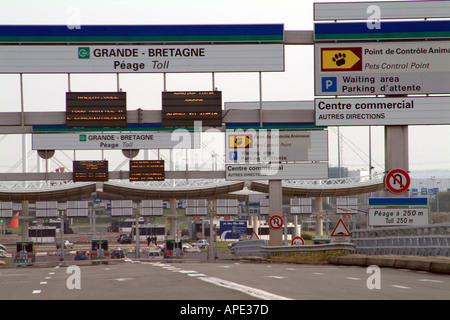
[66,92,127,129]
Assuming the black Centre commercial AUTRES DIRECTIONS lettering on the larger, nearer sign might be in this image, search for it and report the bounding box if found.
[317,100,414,119]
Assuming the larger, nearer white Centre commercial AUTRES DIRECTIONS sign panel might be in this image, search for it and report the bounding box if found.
[315,97,450,126]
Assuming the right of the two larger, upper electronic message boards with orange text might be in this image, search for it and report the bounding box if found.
[162,91,222,128]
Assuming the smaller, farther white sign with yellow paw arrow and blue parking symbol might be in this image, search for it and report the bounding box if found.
[225,129,328,163]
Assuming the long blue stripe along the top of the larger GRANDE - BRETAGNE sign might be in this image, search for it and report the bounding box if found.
[0,24,284,37]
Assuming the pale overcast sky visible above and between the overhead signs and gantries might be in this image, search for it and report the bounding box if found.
[0,0,450,176]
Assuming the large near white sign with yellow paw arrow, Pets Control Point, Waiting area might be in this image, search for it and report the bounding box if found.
[314,41,450,96]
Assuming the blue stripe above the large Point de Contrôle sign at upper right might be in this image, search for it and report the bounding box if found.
[314,20,450,34]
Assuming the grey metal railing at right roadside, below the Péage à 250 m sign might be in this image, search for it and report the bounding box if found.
[351,223,450,257]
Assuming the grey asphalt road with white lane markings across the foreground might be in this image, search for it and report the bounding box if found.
[0,260,450,302]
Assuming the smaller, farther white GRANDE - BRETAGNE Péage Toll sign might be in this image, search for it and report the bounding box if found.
[32,131,201,150]
